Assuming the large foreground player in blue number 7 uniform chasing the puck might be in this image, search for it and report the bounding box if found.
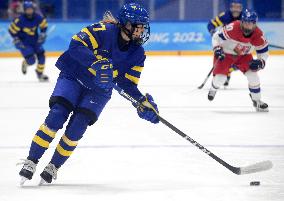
[19,3,159,184]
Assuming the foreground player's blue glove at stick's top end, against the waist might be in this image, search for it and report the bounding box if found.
[88,58,113,89]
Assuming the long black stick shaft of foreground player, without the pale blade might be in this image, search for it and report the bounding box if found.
[113,85,240,174]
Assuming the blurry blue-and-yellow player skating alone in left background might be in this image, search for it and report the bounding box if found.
[9,1,48,82]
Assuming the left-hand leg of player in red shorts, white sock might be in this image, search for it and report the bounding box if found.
[208,54,233,101]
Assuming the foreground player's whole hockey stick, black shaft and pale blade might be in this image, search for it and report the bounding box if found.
[113,84,272,175]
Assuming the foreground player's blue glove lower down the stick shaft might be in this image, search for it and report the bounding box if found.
[137,94,160,124]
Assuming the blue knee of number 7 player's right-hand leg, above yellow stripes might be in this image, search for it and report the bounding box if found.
[65,110,94,141]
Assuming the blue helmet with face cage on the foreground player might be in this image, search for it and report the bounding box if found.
[117,3,150,45]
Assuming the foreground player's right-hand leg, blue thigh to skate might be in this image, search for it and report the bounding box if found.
[41,90,110,183]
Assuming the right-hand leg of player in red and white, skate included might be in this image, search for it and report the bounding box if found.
[238,55,268,112]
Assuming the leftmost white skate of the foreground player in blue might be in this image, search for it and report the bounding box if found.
[17,159,37,186]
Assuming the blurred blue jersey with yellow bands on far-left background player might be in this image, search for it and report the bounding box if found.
[9,13,48,45]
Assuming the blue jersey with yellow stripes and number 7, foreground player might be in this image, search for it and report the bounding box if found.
[56,22,146,98]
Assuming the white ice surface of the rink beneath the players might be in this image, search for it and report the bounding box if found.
[0,56,284,201]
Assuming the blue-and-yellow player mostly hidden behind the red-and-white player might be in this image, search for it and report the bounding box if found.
[207,0,243,87]
